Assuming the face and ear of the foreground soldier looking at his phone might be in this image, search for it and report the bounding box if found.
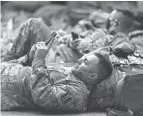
[72,54,100,84]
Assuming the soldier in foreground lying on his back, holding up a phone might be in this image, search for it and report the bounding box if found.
[1,42,112,112]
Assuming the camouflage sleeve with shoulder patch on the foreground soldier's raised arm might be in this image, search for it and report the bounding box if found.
[30,61,89,111]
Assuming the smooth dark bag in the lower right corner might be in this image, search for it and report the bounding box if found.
[115,73,143,116]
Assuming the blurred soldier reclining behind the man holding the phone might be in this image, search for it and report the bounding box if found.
[48,9,143,62]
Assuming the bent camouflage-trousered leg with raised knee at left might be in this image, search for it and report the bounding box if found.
[2,18,51,61]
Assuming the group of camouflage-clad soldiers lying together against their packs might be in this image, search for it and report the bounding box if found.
[1,8,143,111]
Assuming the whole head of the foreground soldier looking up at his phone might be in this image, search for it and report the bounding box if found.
[72,53,112,88]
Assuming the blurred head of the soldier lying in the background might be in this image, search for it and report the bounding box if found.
[107,8,134,34]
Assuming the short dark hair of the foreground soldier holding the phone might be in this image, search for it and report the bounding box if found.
[94,53,113,81]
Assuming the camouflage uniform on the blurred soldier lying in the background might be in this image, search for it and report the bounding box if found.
[50,29,113,63]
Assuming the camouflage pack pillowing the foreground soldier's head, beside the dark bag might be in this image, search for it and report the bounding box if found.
[88,48,143,111]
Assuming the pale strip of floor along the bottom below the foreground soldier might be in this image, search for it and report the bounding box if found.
[1,111,106,116]
